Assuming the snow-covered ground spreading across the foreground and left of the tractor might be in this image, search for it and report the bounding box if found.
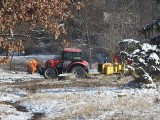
[0,55,160,120]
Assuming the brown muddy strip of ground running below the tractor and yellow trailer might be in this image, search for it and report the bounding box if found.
[8,76,134,93]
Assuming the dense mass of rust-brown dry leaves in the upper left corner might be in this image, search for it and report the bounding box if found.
[0,0,83,38]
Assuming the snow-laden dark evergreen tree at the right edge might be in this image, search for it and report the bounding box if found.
[119,0,160,84]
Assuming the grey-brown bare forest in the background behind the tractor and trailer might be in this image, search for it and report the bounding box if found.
[2,0,160,62]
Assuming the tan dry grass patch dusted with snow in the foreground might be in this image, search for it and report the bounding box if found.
[22,88,154,120]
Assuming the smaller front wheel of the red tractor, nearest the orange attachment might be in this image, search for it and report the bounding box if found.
[44,68,57,79]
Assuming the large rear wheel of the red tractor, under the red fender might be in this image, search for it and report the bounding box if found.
[71,66,86,78]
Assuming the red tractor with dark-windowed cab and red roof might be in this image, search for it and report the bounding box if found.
[44,48,89,79]
